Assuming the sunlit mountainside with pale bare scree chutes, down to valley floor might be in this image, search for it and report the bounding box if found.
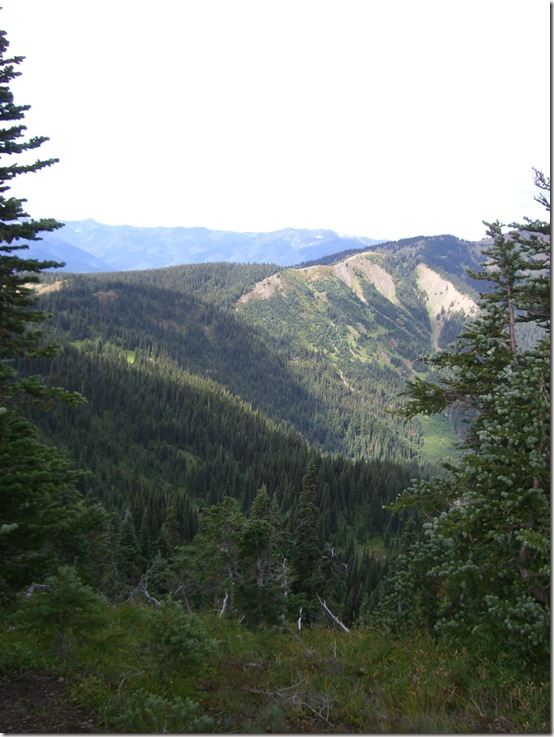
[237,237,477,457]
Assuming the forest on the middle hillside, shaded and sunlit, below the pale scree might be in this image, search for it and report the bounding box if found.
[34,264,422,461]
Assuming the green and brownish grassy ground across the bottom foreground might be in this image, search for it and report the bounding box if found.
[0,605,550,734]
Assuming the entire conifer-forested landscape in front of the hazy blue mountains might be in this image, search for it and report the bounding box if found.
[0,18,551,734]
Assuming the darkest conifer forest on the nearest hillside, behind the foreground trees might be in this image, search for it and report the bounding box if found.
[21,330,415,596]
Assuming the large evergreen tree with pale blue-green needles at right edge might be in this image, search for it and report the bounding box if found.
[375,175,550,663]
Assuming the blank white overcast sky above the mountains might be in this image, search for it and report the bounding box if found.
[0,0,550,239]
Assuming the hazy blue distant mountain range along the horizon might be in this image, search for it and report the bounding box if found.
[28,219,383,273]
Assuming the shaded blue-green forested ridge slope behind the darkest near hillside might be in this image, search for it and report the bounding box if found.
[36,267,417,460]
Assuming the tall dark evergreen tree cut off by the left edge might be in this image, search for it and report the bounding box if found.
[0,24,98,590]
